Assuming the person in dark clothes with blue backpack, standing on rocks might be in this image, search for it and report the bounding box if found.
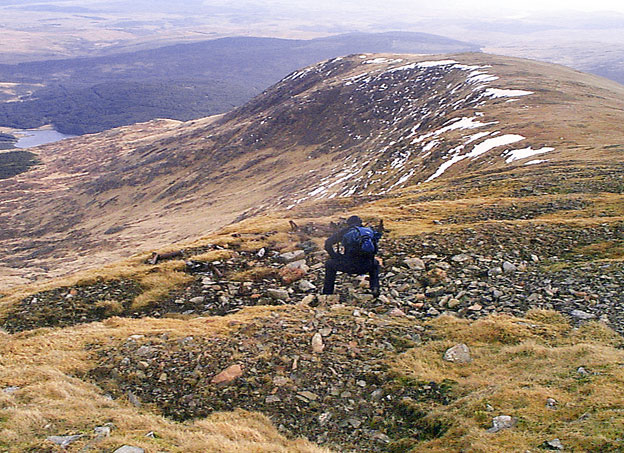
[323,215,381,297]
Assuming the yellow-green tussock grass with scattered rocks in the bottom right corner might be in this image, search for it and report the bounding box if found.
[393,311,624,452]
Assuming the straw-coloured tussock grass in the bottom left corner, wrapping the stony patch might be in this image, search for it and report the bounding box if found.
[0,307,329,453]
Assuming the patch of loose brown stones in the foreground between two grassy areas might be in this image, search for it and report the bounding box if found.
[89,305,453,451]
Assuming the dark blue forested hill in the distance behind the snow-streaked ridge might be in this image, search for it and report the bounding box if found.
[0,32,479,135]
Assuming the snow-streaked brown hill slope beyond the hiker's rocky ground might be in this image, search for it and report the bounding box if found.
[0,54,624,286]
